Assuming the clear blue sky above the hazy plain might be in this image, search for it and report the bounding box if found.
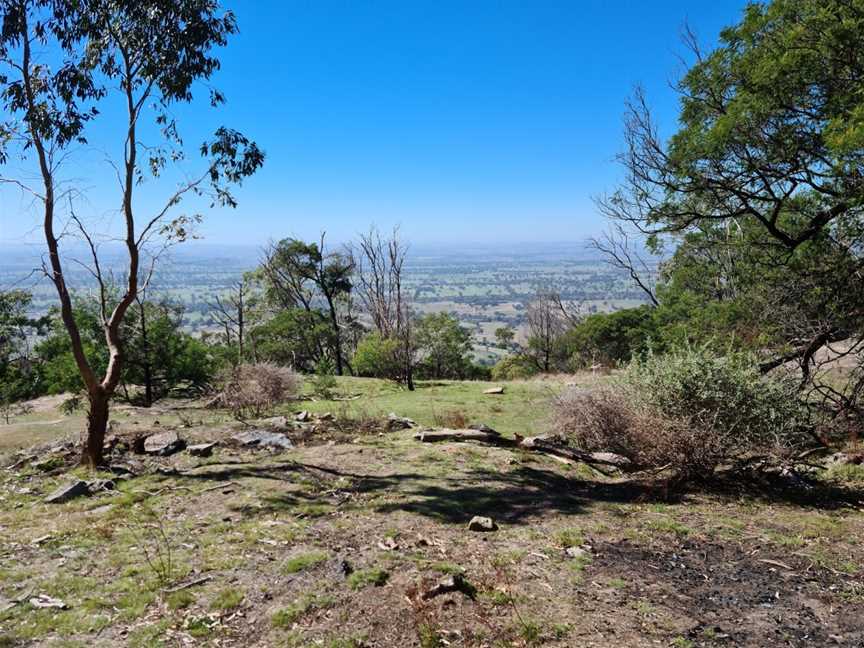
[0,0,744,249]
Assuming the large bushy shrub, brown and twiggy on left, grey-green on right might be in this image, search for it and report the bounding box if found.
[555,347,808,479]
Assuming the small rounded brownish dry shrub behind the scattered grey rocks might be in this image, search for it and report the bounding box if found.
[219,362,302,419]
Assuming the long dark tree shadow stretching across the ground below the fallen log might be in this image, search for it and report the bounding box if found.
[155,461,864,525]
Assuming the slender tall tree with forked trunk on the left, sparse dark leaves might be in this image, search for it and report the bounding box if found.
[0,0,264,466]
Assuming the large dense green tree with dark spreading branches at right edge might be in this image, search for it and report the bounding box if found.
[599,0,864,428]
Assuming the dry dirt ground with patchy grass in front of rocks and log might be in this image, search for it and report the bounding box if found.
[0,404,864,648]
